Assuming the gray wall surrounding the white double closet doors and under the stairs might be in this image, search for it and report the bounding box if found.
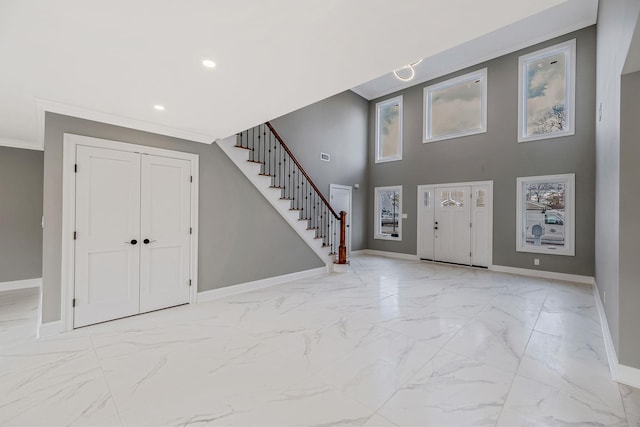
[42,113,324,322]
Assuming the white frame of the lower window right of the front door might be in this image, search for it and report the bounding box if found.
[516,173,576,256]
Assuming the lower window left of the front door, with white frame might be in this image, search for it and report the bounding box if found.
[374,186,402,240]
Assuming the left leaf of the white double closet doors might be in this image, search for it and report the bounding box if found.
[73,146,141,327]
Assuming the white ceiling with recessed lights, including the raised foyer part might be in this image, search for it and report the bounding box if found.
[0,0,597,147]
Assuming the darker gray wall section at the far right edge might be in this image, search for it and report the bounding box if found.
[618,72,640,368]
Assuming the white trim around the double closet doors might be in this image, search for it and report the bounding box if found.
[60,133,200,331]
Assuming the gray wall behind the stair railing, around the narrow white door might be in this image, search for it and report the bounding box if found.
[271,91,369,251]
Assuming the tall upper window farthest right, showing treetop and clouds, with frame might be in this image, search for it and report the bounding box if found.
[518,39,576,142]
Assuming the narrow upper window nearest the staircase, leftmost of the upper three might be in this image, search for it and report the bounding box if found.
[376,96,402,163]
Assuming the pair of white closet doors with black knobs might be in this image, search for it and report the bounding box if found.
[73,146,191,327]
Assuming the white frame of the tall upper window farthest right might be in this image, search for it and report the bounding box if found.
[518,39,576,142]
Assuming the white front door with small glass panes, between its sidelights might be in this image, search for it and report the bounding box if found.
[434,186,471,265]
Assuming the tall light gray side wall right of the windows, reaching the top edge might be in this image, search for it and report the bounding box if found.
[596,0,640,367]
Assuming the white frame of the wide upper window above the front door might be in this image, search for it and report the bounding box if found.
[422,68,487,143]
